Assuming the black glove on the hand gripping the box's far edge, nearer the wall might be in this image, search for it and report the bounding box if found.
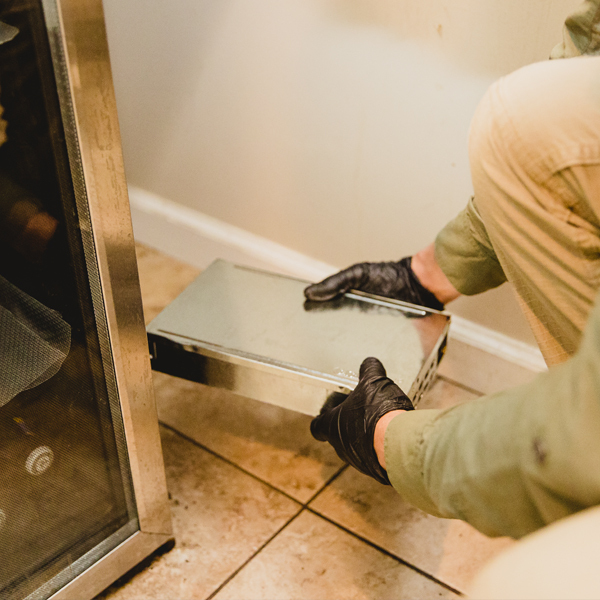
[304,256,444,310]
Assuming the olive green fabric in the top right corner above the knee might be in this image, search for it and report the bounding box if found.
[550,0,600,58]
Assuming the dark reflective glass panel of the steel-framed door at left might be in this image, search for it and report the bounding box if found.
[0,0,137,598]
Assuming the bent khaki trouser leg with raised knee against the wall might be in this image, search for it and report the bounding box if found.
[469,57,600,364]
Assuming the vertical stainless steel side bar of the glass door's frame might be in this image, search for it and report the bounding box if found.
[49,0,172,540]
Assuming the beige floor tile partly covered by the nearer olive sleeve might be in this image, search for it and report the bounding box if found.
[311,379,511,591]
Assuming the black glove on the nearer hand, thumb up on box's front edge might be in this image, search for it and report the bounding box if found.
[310,358,414,485]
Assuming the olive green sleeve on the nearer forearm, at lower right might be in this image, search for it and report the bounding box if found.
[385,294,600,538]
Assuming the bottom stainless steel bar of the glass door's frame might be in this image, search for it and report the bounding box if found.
[50,531,172,600]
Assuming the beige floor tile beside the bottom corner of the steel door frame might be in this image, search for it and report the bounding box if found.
[101,428,299,600]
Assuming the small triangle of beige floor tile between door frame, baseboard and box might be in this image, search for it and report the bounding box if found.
[135,243,199,323]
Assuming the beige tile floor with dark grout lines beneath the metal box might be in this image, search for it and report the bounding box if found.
[99,245,529,600]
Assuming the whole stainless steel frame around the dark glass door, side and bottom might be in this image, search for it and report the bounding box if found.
[28,0,173,600]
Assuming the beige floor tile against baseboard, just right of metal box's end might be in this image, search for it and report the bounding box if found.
[438,339,536,394]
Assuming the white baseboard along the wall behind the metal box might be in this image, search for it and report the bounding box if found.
[129,186,546,372]
